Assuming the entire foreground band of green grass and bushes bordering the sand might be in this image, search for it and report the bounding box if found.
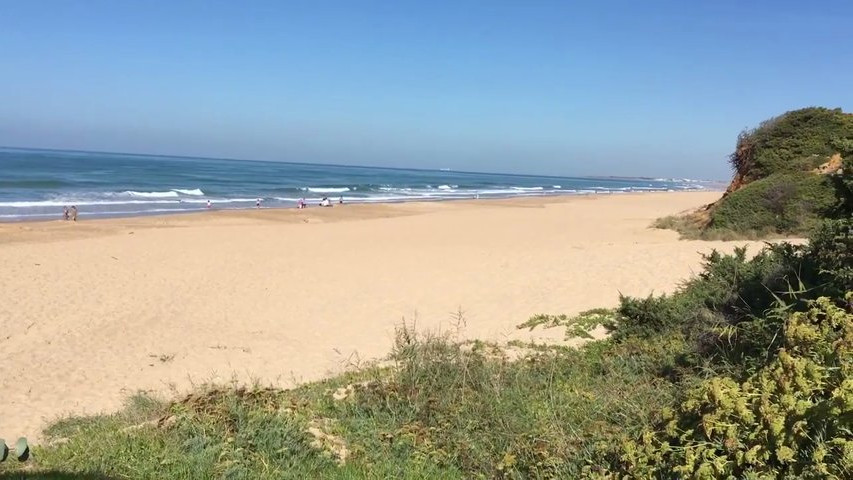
[0,111,853,479]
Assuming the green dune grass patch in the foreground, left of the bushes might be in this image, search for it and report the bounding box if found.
[0,320,679,479]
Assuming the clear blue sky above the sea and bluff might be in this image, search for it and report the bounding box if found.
[0,0,853,179]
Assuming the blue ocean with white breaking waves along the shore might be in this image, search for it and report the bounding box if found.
[0,147,717,221]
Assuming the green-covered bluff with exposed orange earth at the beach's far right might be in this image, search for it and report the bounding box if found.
[654,107,853,239]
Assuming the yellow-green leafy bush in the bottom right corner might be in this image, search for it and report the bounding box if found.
[600,292,853,479]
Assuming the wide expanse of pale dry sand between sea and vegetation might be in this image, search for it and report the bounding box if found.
[0,192,758,438]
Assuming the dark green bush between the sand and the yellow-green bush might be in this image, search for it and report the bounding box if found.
[604,231,853,373]
